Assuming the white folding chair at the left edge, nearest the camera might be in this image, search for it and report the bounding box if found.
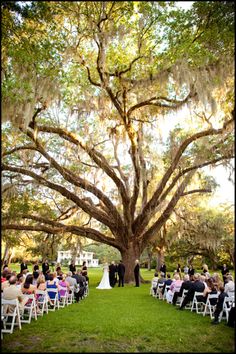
[1,298,21,335]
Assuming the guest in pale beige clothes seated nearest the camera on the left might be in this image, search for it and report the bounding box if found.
[2,276,28,313]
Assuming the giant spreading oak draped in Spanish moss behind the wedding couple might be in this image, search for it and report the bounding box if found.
[2,2,234,281]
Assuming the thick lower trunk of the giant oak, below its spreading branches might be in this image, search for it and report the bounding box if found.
[121,243,141,283]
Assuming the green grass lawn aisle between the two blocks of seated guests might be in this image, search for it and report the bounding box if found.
[1,267,235,353]
